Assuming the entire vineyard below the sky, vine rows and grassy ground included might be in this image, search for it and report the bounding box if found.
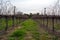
[0,15,60,40]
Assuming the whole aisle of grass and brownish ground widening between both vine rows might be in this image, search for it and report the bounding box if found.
[8,19,57,40]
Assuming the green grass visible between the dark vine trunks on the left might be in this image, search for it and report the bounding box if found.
[0,18,21,30]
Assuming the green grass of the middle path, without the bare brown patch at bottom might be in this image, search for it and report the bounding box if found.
[7,19,39,40]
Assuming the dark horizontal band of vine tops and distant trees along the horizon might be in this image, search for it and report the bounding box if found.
[0,13,60,19]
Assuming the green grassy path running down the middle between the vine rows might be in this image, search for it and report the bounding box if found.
[8,19,40,40]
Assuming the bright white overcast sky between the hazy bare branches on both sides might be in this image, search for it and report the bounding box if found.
[11,0,57,13]
